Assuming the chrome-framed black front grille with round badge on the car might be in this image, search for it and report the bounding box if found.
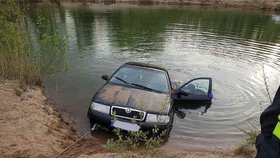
[111,106,146,121]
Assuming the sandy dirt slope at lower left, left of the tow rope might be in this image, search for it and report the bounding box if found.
[0,81,74,157]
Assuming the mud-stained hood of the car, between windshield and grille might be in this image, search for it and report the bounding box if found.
[94,84,171,114]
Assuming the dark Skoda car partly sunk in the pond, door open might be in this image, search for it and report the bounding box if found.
[88,62,213,131]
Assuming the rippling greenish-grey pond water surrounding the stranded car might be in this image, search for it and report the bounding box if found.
[27,4,280,151]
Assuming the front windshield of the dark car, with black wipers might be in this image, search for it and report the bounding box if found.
[110,66,169,93]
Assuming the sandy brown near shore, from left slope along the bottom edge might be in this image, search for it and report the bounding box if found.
[0,80,254,158]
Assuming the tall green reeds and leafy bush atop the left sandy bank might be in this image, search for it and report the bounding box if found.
[0,1,67,86]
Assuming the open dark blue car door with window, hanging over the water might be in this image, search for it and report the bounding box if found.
[172,77,213,104]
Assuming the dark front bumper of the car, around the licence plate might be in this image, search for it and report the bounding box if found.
[88,109,171,131]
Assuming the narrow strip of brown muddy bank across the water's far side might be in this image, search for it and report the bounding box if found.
[37,0,280,11]
